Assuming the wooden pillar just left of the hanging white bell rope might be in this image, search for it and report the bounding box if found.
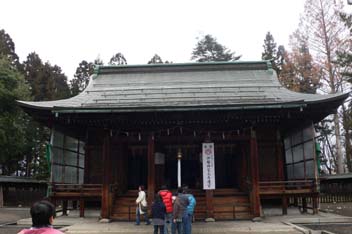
[148,136,155,204]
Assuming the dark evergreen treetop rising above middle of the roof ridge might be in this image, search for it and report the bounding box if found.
[191,34,241,62]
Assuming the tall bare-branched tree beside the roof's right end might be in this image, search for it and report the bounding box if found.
[299,0,347,173]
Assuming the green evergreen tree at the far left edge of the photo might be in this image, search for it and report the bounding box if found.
[0,56,29,175]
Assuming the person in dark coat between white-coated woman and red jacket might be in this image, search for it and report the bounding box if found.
[152,194,166,234]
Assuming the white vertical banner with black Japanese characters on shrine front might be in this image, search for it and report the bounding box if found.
[202,143,215,189]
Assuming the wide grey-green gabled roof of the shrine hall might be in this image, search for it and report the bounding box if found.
[18,61,348,113]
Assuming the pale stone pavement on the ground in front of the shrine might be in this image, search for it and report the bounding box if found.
[12,209,352,234]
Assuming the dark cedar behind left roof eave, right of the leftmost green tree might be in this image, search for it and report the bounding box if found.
[23,52,70,179]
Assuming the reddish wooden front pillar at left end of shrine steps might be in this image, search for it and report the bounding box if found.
[101,132,111,219]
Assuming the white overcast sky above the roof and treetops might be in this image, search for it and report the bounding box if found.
[0,0,305,79]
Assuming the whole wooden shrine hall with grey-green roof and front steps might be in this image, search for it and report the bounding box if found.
[18,61,348,220]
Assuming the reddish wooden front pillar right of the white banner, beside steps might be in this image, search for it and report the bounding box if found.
[250,129,260,217]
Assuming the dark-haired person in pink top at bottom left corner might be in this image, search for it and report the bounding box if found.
[18,200,63,234]
